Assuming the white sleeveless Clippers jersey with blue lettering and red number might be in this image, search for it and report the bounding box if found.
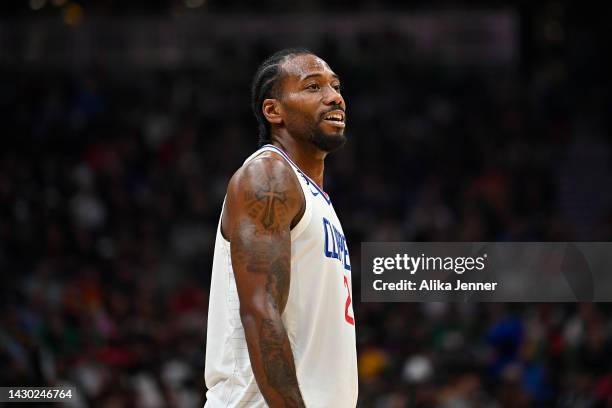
[205,145,357,408]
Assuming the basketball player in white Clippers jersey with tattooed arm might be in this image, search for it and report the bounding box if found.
[205,49,357,408]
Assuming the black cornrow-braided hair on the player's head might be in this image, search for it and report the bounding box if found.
[251,48,312,146]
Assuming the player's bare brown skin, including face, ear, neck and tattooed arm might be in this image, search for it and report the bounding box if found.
[221,54,345,408]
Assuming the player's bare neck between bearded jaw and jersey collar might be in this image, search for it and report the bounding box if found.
[272,134,327,189]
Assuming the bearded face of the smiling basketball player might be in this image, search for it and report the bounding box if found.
[278,54,346,152]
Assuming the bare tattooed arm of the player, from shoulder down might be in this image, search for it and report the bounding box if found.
[225,157,304,407]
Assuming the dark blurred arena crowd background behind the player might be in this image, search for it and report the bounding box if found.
[0,0,612,408]
